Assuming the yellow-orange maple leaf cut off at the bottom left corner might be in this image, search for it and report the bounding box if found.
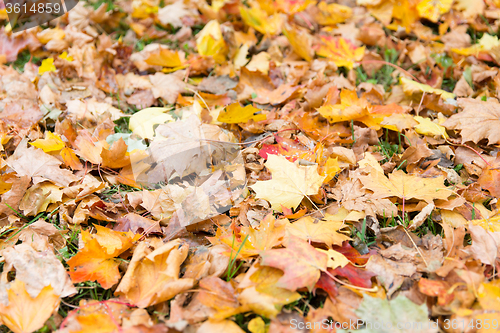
[0,279,60,333]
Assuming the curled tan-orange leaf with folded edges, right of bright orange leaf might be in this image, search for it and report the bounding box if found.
[115,239,194,308]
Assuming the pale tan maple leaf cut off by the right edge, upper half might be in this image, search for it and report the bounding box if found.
[443,98,500,144]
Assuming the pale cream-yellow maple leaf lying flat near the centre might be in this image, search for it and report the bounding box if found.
[250,155,325,211]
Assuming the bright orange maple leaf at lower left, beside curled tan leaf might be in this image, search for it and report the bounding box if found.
[67,225,140,289]
